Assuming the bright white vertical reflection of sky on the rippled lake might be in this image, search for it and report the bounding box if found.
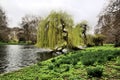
[6,45,22,71]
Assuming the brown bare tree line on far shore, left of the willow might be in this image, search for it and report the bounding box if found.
[0,7,41,44]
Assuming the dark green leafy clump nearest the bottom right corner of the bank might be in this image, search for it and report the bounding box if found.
[87,66,103,77]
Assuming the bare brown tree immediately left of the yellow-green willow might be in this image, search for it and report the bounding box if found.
[21,15,41,42]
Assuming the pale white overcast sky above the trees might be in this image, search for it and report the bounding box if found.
[0,0,106,31]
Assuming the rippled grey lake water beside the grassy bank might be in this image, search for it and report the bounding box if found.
[0,45,54,74]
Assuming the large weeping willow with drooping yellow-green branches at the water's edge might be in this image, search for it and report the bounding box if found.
[37,11,81,49]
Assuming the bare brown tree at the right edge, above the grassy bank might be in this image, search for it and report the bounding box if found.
[96,0,120,46]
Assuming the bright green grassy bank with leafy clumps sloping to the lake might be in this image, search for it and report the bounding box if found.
[0,45,120,80]
